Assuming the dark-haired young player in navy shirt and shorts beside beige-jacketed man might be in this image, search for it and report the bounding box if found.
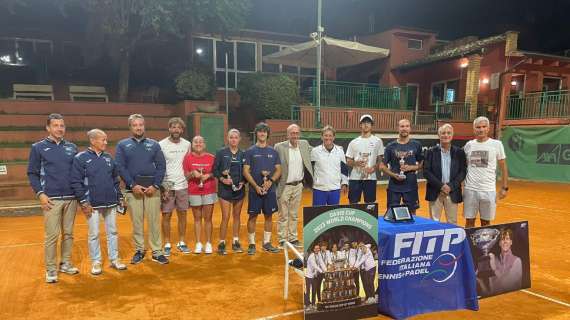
[243,122,281,255]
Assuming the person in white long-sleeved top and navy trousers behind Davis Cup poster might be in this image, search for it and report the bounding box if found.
[311,125,348,206]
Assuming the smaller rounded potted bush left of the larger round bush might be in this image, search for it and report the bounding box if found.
[174,67,218,112]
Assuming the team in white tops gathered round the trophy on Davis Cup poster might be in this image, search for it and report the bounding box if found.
[305,241,377,307]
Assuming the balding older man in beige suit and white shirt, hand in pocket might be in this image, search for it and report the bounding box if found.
[275,124,313,248]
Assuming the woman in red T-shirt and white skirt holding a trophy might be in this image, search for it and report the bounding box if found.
[182,136,218,254]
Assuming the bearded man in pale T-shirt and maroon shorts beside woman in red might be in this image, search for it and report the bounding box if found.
[159,117,190,257]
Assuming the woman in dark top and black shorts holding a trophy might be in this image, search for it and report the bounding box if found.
[214,129,245,255]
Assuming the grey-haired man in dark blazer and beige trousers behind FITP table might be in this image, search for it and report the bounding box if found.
[424,123,467,224]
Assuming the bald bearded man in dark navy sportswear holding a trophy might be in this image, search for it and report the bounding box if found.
[380,119,424,214]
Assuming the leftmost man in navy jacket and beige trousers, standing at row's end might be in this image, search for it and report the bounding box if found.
[28,113,79,283]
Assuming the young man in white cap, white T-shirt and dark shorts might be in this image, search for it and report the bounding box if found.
[346,114,384,203]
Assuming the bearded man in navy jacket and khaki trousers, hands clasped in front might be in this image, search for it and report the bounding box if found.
[115,114,168,264]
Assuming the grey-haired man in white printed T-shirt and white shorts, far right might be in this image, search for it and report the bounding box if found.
[463,117,509,228]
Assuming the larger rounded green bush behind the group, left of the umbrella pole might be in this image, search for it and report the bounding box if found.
[238,73,299,120]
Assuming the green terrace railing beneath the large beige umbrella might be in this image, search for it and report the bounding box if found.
[303,81,408,110]
